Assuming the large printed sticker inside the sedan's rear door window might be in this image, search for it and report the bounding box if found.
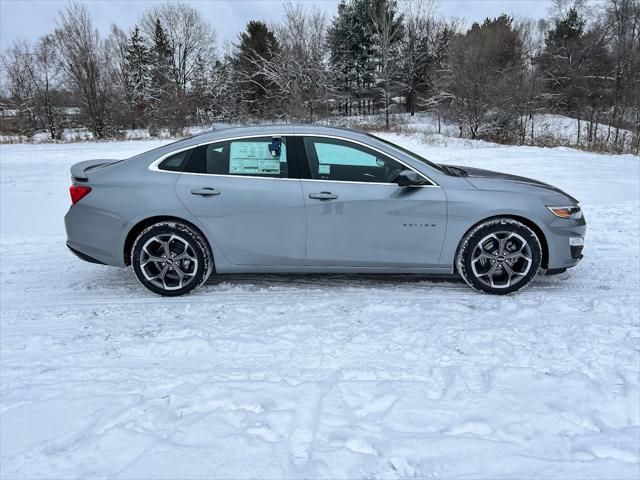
[229,141,287,175]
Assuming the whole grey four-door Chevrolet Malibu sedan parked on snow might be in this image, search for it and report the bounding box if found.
[65,125,586,296]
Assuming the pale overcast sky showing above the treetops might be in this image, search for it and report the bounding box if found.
[0,0,551,50]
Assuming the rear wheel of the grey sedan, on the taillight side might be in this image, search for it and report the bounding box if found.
[131,222,213,297]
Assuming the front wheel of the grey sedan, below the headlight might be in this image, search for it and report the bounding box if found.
[456,218,542,295]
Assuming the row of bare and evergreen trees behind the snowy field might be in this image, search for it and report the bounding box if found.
[0,0,640,152]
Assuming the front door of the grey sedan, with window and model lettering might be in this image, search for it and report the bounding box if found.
[302,137,446,268]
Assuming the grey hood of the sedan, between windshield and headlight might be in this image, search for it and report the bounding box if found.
[445,165,578,203]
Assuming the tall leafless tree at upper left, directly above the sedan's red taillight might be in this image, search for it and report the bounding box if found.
[54,4,111,138]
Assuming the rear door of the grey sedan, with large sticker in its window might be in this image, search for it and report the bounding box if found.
[175,137,305,266]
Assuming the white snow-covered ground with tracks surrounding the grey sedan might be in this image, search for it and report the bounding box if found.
[0,135,640,479]
